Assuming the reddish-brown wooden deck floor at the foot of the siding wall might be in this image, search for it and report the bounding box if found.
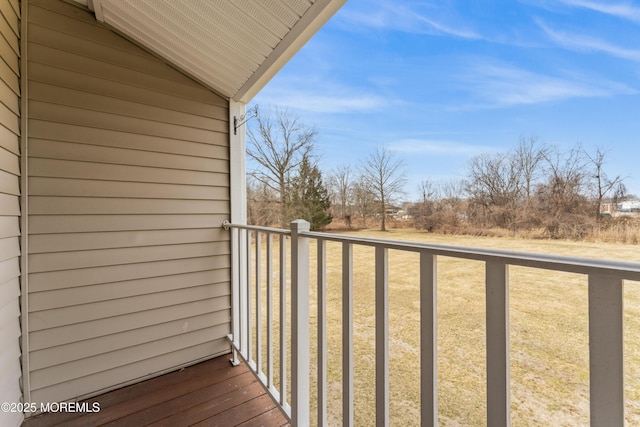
[22,355,289,427]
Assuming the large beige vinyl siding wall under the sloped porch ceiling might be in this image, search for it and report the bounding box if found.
[27,0,231,402]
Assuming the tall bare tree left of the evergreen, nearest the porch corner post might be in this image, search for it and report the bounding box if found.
[247,108,318,228]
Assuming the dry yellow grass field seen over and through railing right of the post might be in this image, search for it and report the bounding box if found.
[250,230,640,426]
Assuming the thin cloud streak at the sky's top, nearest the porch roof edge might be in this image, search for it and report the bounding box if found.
[340,1,482,39]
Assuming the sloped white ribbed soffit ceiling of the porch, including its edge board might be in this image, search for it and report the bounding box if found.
[82,0,346,102]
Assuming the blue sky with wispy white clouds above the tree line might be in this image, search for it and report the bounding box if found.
[252,0,640,200]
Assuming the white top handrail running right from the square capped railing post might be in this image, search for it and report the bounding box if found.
[301,231,640,281]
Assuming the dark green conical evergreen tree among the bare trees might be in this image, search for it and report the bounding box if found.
[291,156,333,230]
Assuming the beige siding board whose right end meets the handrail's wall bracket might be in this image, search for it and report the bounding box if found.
[29,231,229,253]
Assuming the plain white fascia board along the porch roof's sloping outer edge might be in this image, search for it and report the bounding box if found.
[232,0,347,103]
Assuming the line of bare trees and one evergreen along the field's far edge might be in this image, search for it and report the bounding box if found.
[247,108,627,238]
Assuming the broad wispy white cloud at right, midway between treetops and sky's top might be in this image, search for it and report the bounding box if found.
[462,63,636,108]
